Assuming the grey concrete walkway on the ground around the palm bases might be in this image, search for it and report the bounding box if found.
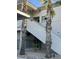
[17,52,61,59]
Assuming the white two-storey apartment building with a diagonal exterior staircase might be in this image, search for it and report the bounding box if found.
[17,2,61,56]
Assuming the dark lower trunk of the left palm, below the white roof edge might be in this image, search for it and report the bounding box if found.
[20,19,26,55]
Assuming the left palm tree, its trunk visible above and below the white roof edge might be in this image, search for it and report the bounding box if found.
[20,0,27,55]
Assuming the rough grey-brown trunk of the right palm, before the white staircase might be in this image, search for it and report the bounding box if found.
[46,0,52,58]
